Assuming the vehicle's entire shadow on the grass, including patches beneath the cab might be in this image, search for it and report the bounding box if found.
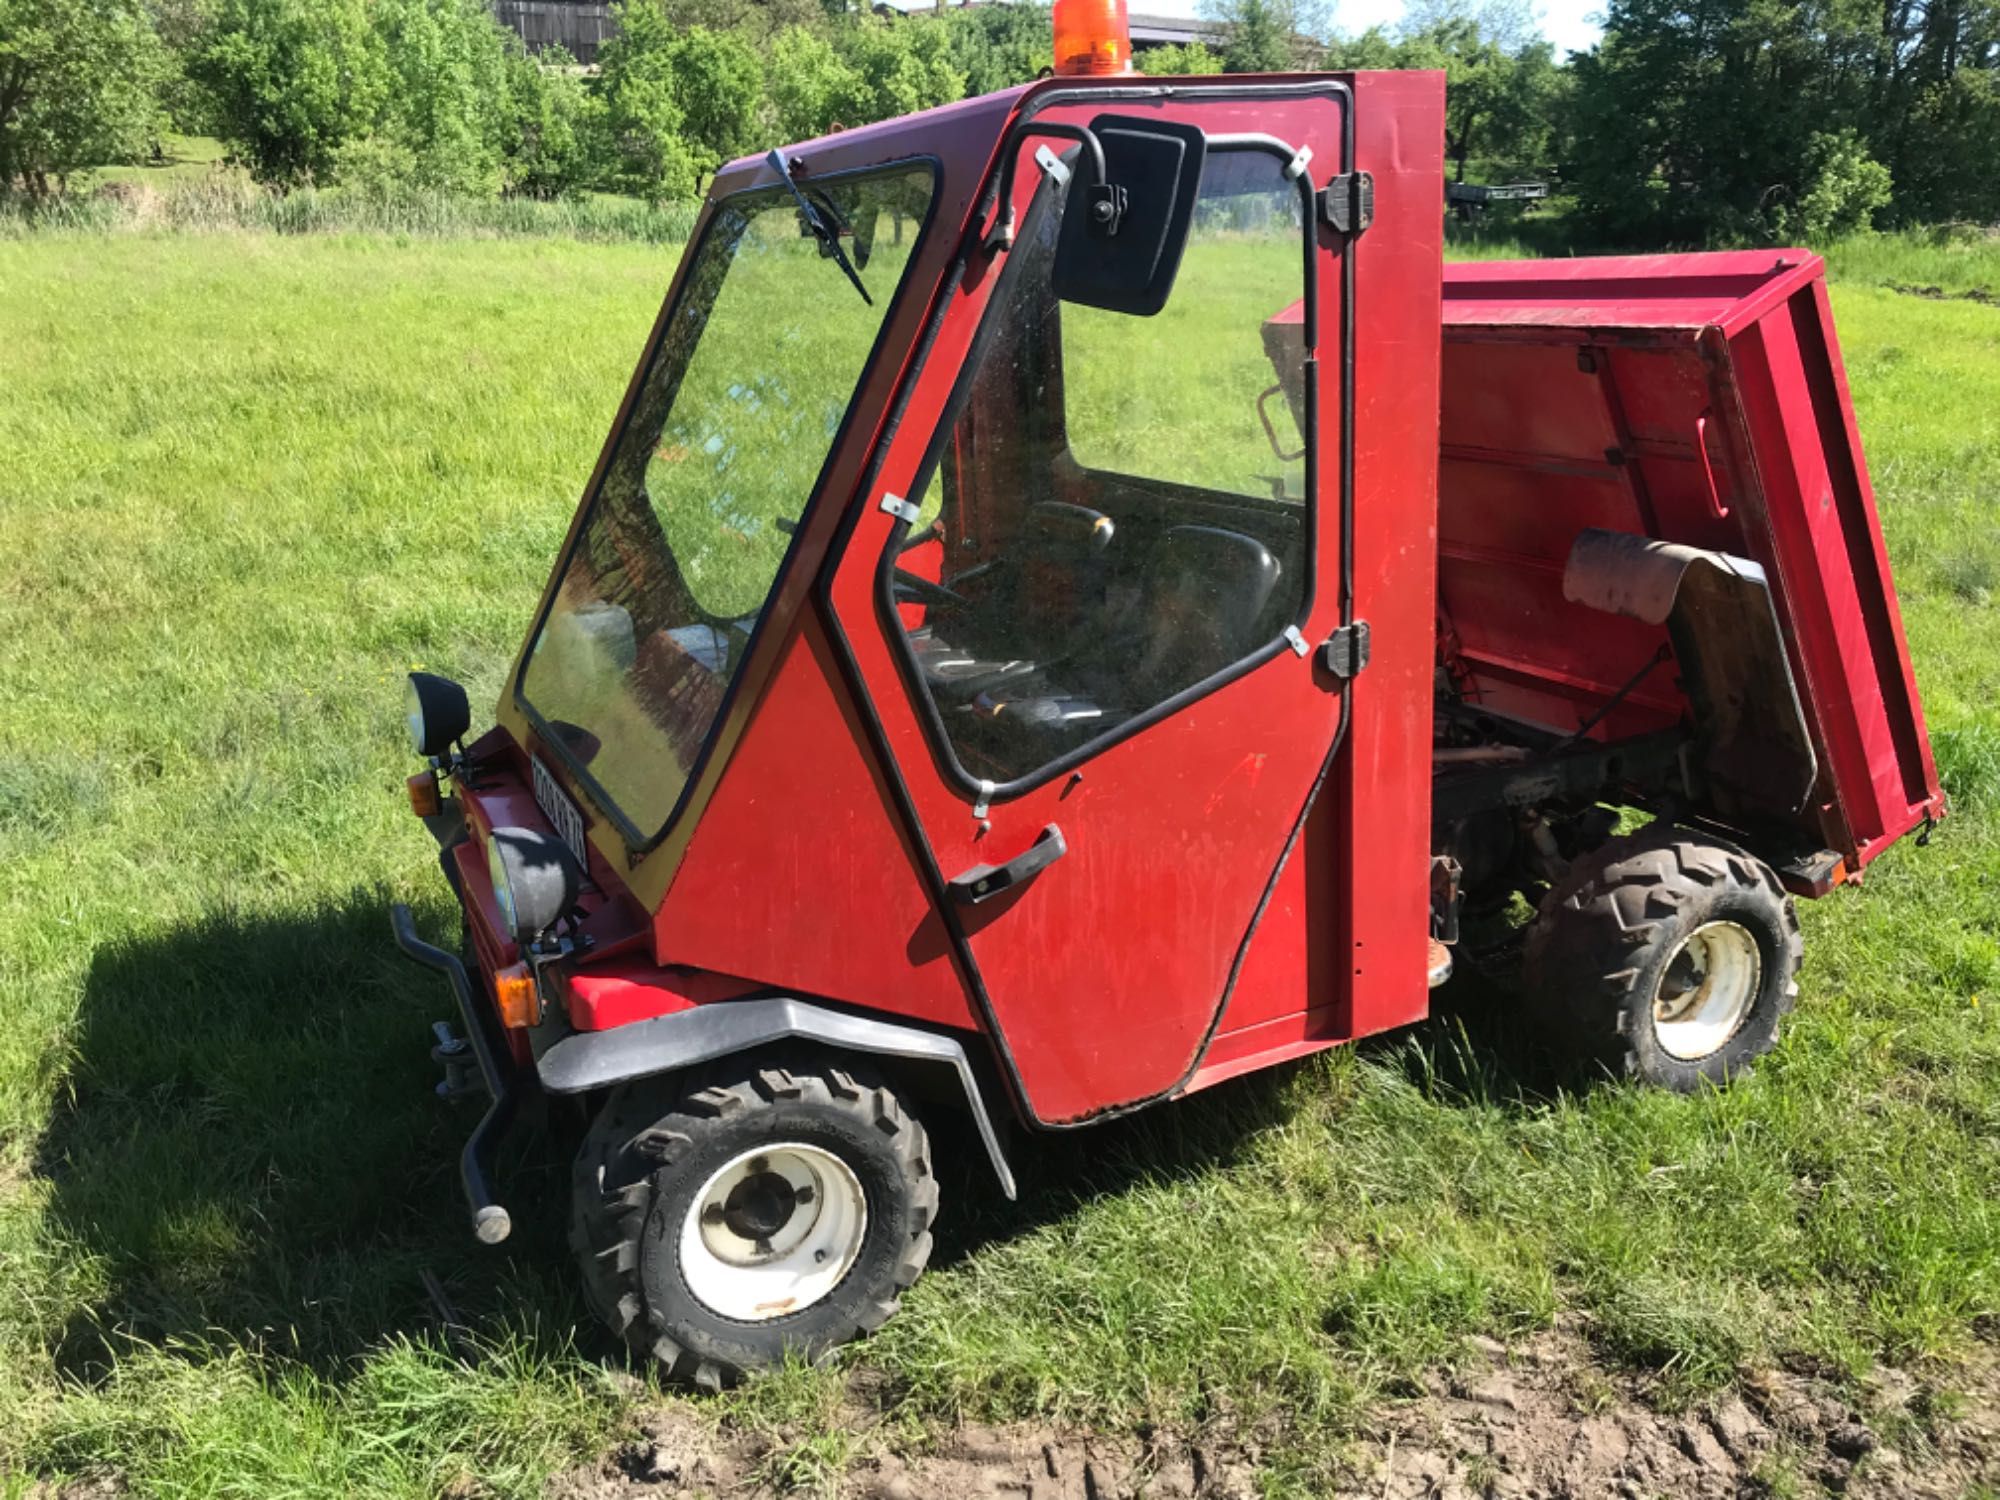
[36,890,1550,1380]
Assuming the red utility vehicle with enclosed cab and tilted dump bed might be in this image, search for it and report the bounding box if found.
[396,50,1944,1384]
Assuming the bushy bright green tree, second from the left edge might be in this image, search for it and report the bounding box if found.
[195,0,390,184]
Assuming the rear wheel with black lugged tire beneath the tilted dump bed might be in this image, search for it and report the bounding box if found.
[1522,824,1804,1092]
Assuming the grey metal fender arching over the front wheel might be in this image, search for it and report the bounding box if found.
[536,996,1014,1198]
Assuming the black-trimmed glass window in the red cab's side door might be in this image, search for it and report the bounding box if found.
[884,150,1312,784]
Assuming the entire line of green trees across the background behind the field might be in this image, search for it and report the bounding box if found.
[0,0,2000,246]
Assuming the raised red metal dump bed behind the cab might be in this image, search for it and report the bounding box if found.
[1438,250,1944,870]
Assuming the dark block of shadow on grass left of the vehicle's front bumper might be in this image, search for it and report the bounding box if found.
[36,890,584,1380]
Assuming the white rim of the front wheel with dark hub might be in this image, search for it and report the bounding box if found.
[680,1142,868,1322]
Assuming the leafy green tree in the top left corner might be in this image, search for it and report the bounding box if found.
[0,0,164,198]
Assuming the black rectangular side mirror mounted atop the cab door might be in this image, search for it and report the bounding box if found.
[1050,114,1208,318]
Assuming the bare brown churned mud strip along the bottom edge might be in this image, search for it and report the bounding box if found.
[550,1336,2000,1500]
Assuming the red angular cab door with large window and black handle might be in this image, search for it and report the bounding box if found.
[828,80,1352,1124]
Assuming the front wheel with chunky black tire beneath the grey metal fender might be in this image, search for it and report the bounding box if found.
[570,1056,938,1390]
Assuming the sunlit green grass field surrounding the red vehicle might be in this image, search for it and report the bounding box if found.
[0,234,2000,1498]
